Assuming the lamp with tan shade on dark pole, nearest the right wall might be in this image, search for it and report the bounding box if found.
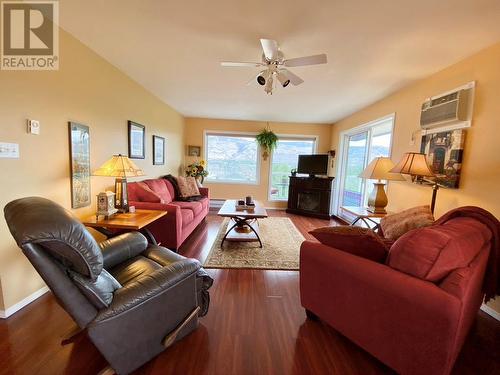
[390,152,439,213]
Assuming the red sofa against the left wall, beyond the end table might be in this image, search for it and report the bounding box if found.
[127,178,210,250]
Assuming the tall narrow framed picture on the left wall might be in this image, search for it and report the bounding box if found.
[68,122,91,208]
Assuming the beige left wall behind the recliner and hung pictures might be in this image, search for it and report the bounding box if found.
[0,31,184,310]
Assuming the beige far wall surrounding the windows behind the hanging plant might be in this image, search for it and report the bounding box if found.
[185,118,331,207]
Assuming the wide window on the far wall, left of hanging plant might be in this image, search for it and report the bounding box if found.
[205,133,259,184]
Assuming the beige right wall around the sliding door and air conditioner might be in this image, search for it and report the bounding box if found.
[332,44,500,311]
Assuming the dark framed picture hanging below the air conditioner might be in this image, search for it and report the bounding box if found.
[420,129,465,189]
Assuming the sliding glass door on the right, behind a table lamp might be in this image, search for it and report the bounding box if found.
[337,115,394,214]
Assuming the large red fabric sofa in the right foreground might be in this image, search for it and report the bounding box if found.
[300,209,499,375]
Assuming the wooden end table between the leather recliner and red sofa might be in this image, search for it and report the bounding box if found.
[83,210,167,245]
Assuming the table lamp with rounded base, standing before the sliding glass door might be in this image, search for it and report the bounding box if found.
[359,157,404,214]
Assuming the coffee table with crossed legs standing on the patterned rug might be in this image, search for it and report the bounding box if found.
[217,199,267,248]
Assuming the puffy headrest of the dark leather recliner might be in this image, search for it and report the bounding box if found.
[4,197,103,280]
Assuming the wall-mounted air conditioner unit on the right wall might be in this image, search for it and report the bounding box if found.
[420,82,474,129]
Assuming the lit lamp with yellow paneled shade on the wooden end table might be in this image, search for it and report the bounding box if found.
[93,154,144,212]
